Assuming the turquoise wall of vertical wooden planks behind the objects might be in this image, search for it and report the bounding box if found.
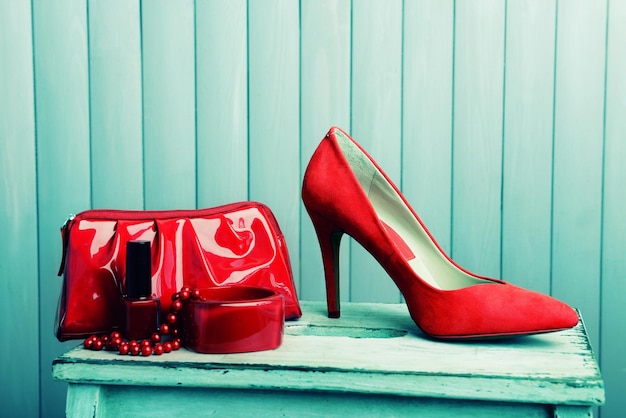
[0,0,626,417]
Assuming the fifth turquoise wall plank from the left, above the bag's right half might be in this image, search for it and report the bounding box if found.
[196,0,248,207]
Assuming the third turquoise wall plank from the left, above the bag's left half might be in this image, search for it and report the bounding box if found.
[89,0,143,209]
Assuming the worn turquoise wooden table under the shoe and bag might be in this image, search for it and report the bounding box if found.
[52,302,604,417]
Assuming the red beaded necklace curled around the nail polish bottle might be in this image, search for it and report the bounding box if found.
[83,287,200,357]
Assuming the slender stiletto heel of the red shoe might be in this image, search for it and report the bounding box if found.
[310,214,343,318]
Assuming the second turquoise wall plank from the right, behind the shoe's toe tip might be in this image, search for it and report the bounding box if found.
[552,0,606,348]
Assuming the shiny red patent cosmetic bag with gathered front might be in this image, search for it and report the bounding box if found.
[55,202,302,341]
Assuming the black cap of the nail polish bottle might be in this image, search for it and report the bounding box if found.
[126,241,152,299]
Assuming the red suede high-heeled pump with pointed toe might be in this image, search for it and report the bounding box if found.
[302,128,578,339]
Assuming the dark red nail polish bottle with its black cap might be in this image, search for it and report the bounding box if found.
[122,241,160,340]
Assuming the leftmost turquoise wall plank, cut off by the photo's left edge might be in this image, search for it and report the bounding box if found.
[0,0,39,416]
